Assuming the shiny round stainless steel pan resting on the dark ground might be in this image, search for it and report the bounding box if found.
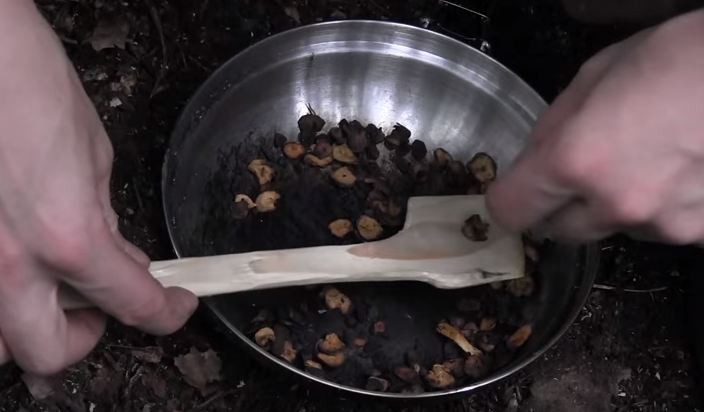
[163,21,598,399]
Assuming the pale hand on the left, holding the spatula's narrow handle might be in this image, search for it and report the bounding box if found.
[0,0,197,375]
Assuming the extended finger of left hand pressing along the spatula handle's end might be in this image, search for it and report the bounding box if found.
[64,219,198,335]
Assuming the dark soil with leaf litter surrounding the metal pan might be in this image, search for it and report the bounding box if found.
[0,0,704,412]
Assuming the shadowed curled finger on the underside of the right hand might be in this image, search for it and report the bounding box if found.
[543,200,614,242]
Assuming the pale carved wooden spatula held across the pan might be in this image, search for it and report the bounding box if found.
[61,195,524,309]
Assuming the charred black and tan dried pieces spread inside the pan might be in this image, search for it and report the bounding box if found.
[195,115,537,393]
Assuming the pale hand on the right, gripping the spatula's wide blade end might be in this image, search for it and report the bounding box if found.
[487,10,704,244]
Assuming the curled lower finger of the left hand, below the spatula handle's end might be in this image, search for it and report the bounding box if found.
[0,273,105,375]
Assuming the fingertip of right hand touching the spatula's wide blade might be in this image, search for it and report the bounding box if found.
[486,145,575,231]
